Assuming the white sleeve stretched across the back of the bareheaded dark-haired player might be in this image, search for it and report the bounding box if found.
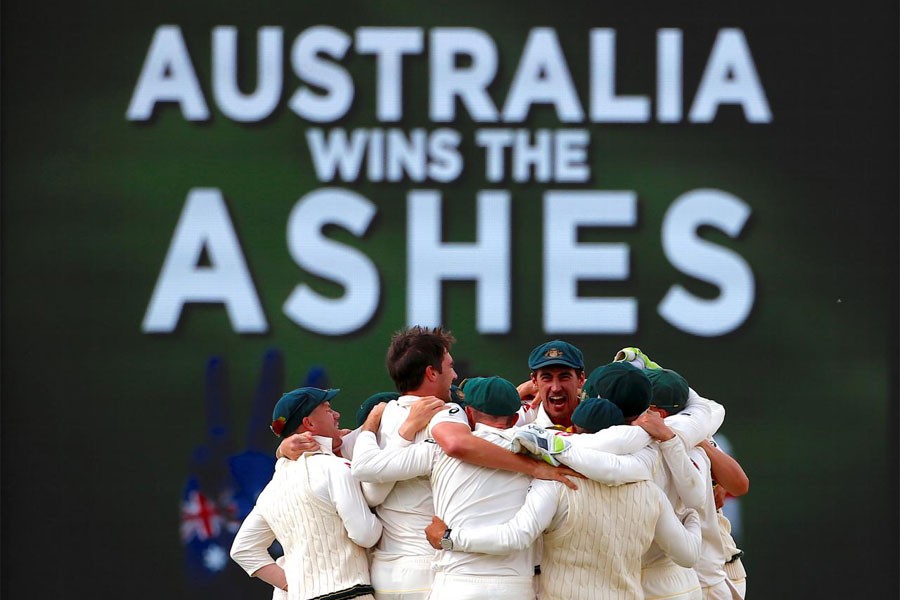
[351,432,438,483]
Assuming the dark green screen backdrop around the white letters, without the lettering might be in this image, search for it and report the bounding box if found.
[2,0,900,599]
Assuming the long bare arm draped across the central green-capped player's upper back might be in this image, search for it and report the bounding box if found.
[431,421,584,490]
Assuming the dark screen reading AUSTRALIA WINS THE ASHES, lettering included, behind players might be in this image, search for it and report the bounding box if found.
[0,0,900,599]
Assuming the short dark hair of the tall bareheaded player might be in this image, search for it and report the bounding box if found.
[385,325,456,394]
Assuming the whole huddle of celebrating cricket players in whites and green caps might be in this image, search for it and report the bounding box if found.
[231,327,749,600]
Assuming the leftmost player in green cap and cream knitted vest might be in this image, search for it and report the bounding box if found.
[231,387,382,600]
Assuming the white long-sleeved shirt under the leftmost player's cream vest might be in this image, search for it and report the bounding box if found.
[231,436,382,575]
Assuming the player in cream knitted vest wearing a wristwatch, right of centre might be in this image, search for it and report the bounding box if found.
[426,400,700,599]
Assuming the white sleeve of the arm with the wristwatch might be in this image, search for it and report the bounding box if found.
[450,479,562,554]
